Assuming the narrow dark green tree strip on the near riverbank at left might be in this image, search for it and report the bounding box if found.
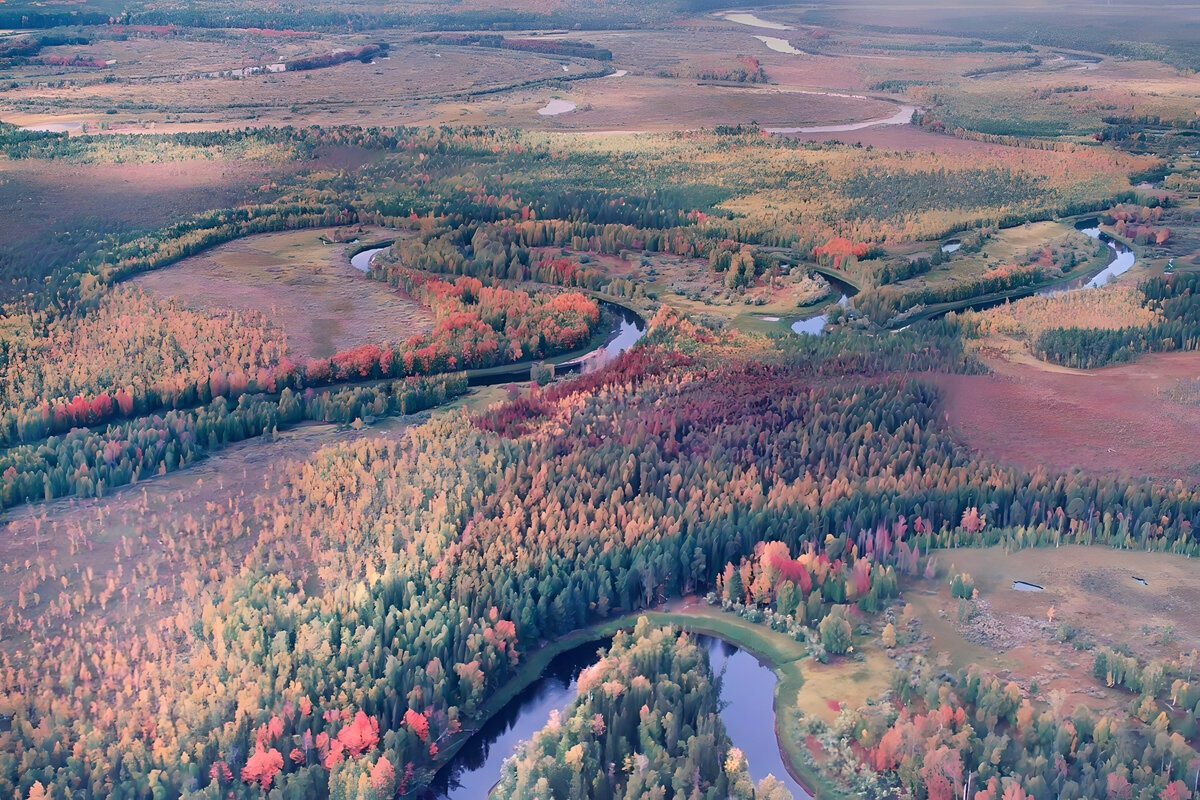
[0,373,467,509]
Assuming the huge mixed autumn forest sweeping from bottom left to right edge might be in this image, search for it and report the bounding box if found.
[7,317,1200,800]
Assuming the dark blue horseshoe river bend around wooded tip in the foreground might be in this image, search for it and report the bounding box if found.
[422,634,812,800]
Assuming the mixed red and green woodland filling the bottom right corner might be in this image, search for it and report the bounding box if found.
[836,656,1198,800]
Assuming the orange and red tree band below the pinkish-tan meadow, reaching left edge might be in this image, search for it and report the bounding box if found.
[0,270,600,445]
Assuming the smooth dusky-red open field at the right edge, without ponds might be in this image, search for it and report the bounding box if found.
[937,353,1200,485]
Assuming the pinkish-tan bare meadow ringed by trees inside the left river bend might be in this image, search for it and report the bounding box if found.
[133,228,433,359]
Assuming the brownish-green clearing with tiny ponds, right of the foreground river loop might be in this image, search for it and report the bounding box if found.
[898,546,1200,714]
